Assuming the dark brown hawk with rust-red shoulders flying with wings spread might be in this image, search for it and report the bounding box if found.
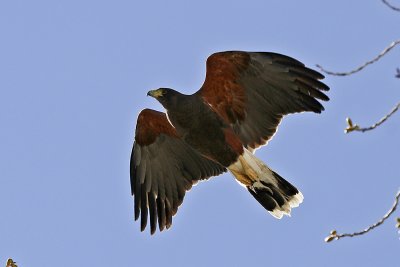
[130,51,329,234]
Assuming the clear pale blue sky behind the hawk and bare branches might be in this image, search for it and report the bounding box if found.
[0,0,400,267]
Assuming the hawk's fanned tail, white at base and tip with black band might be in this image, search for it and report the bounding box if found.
[229,150,303,219]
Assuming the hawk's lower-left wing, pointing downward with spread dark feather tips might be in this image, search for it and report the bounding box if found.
[130,109,226,234]
